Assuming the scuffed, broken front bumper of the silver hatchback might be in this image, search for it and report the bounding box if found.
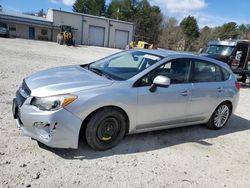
[13,99,82,148]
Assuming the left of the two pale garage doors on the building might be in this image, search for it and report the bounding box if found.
[89,26,105,46]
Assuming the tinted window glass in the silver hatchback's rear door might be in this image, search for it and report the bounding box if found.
[192,60,223,82]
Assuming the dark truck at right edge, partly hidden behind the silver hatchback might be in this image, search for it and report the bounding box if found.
[202,40,250,83]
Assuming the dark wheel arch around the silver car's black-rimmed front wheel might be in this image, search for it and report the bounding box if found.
[79,105,130,139]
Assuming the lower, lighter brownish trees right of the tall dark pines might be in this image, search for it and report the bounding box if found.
[161,16,250,51]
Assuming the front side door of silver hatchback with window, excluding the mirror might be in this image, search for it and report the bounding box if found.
[136,59,192,130]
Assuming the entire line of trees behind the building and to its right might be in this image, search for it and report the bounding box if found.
[73,0,250,51]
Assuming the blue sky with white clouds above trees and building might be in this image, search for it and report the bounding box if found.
[0,0,250,27]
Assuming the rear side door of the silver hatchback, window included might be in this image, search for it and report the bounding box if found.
[190,59,225,121]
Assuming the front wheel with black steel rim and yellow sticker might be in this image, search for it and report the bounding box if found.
[85,107,126,150]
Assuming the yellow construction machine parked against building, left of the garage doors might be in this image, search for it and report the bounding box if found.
[57,25,75,46]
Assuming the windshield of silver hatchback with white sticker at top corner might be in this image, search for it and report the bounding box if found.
[88,50,163,80]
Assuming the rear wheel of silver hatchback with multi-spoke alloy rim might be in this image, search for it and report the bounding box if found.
[206,102,232,130]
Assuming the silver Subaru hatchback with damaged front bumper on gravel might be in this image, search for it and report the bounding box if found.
[12,49,240,150]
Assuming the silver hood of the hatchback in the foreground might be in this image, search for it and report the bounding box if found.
[25,65,113,97]
